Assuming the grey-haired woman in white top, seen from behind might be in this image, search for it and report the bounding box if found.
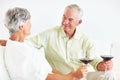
[4,7,87,80]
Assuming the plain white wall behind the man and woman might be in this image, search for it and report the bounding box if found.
[0,0,120,53]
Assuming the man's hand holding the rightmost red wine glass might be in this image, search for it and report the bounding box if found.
[97,60,113,71]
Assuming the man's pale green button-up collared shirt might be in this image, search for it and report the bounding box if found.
[28,26,101,74]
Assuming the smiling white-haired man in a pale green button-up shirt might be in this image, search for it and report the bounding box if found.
[28,4,114,80]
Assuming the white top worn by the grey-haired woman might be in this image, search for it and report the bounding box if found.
[5,40,52,80]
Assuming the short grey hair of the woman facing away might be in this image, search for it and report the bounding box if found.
[4,7,31,34]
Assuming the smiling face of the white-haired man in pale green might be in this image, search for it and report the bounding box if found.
[61,8,79,33]
